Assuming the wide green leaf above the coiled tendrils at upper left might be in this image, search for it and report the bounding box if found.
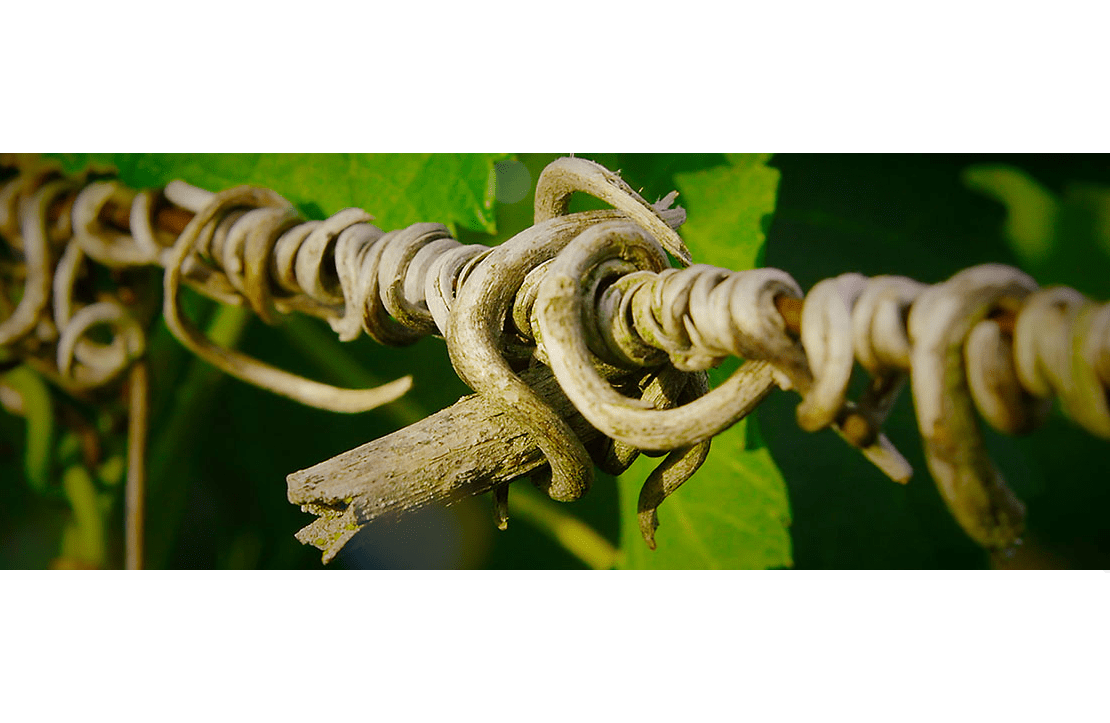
[48,153,507,233]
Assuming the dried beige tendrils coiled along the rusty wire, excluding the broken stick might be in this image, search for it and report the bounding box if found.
[0,158,1110,568]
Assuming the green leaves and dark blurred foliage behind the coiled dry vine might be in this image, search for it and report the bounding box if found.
[0,153,1110,568]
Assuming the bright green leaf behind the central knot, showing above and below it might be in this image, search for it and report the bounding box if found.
[618,154,793,569]
